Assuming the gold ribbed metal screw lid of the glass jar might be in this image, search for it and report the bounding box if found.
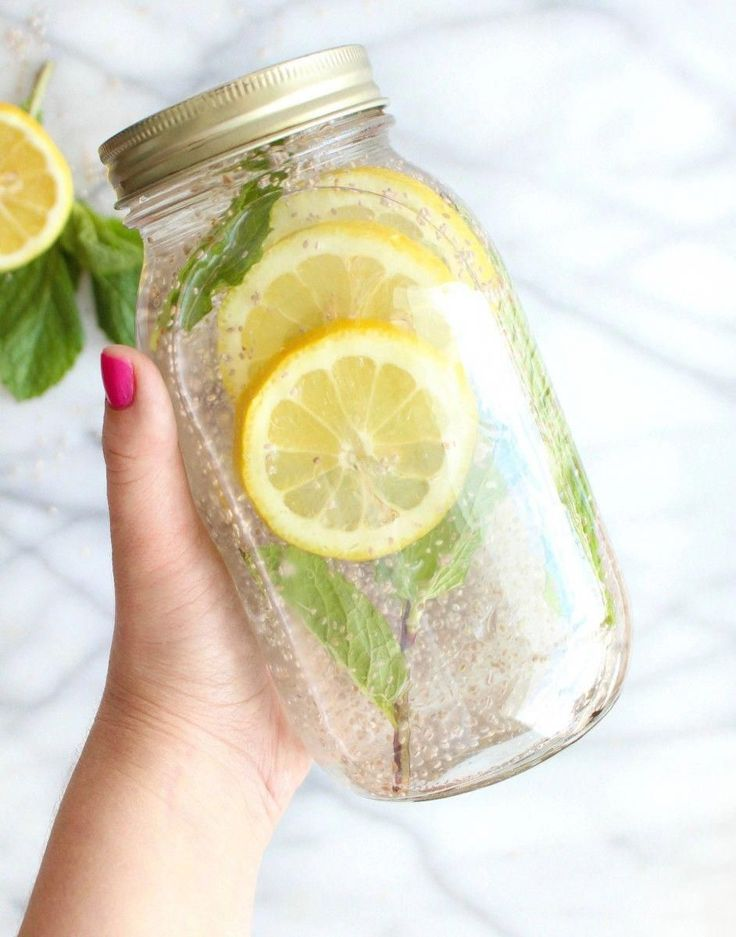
[99,45,387,204]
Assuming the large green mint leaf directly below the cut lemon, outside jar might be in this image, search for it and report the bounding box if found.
[0,245,84,400]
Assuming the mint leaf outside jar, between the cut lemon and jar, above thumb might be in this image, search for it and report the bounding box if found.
[61,202,143,345]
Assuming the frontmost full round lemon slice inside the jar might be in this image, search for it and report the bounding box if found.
[235,322,478,560]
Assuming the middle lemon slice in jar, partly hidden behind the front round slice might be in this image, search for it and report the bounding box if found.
[218,221,452,398]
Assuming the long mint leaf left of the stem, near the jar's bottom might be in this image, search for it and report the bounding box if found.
[259,544,407,726]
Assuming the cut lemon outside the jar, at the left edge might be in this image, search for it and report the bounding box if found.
[0,103,74,270]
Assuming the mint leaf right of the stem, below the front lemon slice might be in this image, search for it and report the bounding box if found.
[376,453,503,622]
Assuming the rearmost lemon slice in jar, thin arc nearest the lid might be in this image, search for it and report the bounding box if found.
[267,166,503,286]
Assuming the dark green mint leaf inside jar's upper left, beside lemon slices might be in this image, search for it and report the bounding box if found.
[158,163,286,331]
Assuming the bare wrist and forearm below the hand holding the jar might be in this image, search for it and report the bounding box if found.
[21,690,273,937]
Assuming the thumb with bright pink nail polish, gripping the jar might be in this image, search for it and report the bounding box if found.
[101,345,231,629]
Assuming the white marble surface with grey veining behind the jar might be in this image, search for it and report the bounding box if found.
[0,0,736,937]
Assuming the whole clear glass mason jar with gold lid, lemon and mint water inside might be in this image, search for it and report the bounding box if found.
[100,46,629,800]
